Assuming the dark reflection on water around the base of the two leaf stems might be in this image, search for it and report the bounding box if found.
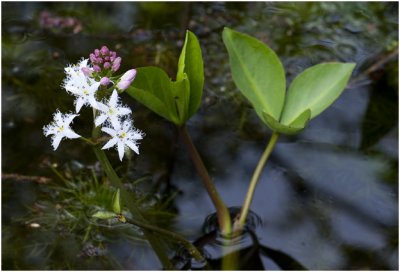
[175,207,307,270]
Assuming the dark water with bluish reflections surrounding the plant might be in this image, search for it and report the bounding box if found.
[2,2,398,270]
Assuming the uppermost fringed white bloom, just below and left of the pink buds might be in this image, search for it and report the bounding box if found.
[63,69,100,113]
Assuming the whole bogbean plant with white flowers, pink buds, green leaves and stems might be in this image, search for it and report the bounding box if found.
[44,28,355,268]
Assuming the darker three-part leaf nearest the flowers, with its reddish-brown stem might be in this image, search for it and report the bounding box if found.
[127,31,231,235]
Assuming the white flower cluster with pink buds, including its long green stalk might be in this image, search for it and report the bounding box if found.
[43,46,180,268]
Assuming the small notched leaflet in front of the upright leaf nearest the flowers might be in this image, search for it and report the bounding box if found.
[171,73,190,126]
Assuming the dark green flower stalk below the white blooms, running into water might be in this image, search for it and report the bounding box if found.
[93,146,174,269]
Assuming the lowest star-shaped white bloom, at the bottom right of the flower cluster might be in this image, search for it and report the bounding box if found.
[101,120,144,161]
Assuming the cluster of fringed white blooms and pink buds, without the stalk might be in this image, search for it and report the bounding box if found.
[43,46,144,161]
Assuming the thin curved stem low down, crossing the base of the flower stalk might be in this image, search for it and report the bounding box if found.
[125,218,205,261]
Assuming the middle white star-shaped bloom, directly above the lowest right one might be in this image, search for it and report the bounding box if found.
[94,90,132,127]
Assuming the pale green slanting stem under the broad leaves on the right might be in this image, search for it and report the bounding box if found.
[234,131,279,231]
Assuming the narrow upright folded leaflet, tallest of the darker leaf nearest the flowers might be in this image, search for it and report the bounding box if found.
[176,31,204,118]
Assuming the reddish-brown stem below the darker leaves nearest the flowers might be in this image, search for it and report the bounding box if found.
[179,125,231,235]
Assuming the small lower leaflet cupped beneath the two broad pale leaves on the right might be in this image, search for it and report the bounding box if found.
[263,110,311,135]
